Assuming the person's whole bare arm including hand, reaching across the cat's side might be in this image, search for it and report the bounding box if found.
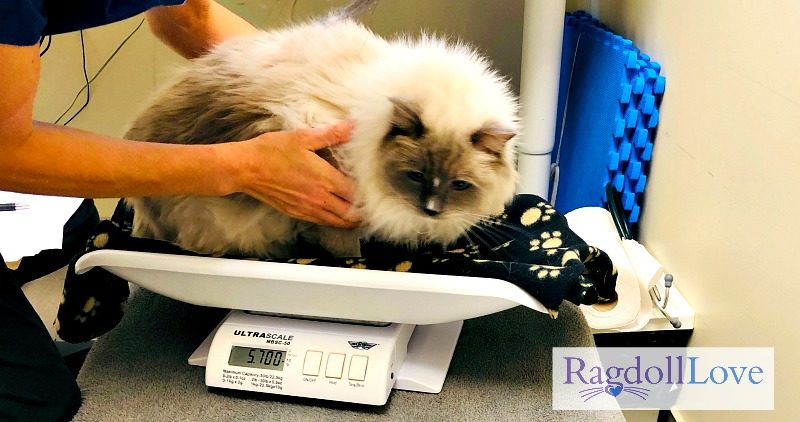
[0,44,354,227]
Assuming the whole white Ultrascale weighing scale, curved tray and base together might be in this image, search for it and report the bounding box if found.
[75,250,547,405]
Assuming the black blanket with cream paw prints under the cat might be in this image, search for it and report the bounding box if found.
[56,195,617,342]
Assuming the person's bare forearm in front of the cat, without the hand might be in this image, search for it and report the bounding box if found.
[0,123,237,198]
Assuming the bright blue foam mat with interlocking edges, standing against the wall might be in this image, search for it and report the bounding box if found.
[553,12,666,226]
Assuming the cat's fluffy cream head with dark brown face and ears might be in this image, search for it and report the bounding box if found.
[348,39,518,244]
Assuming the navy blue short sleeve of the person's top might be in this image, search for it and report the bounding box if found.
[0,0,184,46]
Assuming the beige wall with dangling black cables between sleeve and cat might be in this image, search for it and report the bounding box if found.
[34,16,184,216]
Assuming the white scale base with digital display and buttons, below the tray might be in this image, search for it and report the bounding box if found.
[189,311,462,405]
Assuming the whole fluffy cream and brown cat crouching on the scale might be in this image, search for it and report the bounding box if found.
[127,17,519,257]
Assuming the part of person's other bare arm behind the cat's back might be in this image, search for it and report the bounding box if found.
[146,0,258,59]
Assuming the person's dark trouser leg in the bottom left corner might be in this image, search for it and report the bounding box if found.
[0,252,81,422]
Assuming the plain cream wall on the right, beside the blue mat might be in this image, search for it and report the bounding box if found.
[570,0,800,421]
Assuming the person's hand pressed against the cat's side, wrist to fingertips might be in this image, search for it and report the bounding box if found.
[225,122,360,228]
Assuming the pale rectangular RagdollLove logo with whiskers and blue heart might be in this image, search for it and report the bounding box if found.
[553,347,775,410]
